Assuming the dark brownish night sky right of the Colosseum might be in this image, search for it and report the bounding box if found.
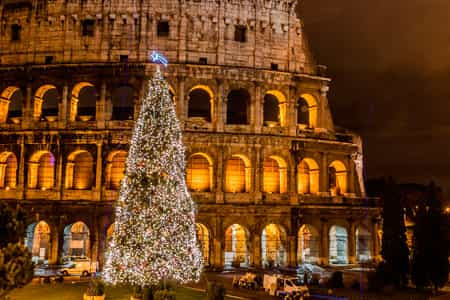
[298,0,450,198]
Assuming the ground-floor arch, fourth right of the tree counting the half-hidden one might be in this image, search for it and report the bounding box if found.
[297,224,320,264]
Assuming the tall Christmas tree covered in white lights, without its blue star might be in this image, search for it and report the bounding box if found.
[104,68,202,287]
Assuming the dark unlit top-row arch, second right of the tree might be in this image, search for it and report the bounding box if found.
[227,89,250,125]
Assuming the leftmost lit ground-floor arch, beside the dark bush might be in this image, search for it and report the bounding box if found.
[25,221,51,264]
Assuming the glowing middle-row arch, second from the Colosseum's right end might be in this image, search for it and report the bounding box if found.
[297,158,320,194]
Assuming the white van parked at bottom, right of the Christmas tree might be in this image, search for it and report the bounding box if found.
[264,274,309,298]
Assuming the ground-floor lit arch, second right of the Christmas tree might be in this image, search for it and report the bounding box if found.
[225,224,250,267]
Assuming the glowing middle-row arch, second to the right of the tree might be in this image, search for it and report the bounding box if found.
[225,154,251,193]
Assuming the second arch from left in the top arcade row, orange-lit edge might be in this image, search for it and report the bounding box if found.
[33,84,59,122]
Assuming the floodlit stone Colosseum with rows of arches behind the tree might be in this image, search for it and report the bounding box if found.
[0,0,381,268]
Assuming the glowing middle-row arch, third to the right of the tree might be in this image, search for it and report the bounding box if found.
[263,155,287,193]
